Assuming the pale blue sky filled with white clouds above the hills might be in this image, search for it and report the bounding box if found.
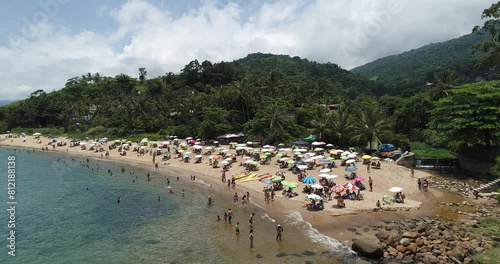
[0,0,494,100]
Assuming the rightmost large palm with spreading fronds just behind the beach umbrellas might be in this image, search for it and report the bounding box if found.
[352,104,393,150]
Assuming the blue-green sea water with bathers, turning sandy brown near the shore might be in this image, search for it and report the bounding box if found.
[0,148,355,264]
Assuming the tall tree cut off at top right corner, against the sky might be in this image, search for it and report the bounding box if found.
[472,2,500,69]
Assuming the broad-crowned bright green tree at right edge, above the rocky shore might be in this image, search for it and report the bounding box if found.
[430,81,500,148]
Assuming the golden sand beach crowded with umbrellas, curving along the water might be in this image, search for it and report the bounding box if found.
[0,135,431,244]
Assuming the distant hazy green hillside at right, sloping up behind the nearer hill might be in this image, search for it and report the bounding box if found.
[351,33,487,92]
